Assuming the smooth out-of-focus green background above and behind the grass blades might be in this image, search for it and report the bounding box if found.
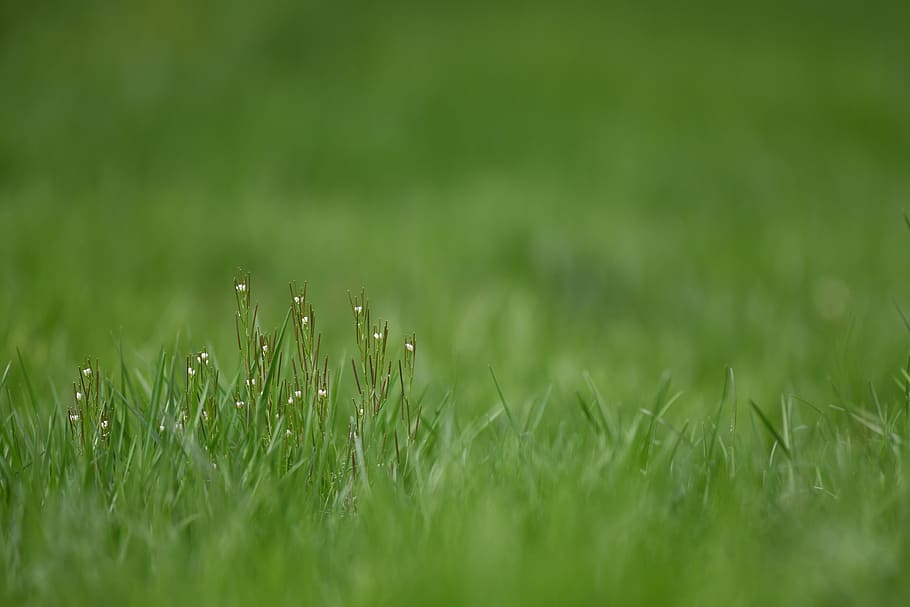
[0,0,910,408]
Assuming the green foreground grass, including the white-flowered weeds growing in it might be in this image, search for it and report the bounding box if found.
[0,275,910,604]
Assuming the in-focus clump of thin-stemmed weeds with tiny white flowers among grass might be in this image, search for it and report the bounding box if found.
[39,274,425,506]
